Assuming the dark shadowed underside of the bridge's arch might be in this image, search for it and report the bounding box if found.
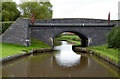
[52,31,89,47]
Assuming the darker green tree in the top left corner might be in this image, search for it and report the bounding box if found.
[2,2,20,21]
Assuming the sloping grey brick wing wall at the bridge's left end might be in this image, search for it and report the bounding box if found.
[0,18,29,46]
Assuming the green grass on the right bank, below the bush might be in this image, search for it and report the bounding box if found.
[86,45,120,63]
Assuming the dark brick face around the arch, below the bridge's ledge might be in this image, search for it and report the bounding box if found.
[31,26,112,46]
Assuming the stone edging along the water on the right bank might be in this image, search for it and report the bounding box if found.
[73,46,120,68]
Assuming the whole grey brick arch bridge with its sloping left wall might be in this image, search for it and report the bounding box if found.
[0,18,117,46]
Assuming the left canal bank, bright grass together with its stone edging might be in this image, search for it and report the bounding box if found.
[0,39,53,63]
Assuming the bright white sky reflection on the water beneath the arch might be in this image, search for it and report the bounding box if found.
[54,41,81,67]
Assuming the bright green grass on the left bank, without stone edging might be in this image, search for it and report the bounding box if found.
[0,39,51,58]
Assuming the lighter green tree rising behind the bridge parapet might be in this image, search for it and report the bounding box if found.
[19,2,52,19]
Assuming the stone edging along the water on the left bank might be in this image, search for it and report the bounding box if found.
[0,48,53,64]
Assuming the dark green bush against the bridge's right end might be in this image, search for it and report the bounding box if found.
[107,27,120,48]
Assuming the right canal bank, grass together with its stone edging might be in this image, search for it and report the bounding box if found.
[73,45,120,68]
